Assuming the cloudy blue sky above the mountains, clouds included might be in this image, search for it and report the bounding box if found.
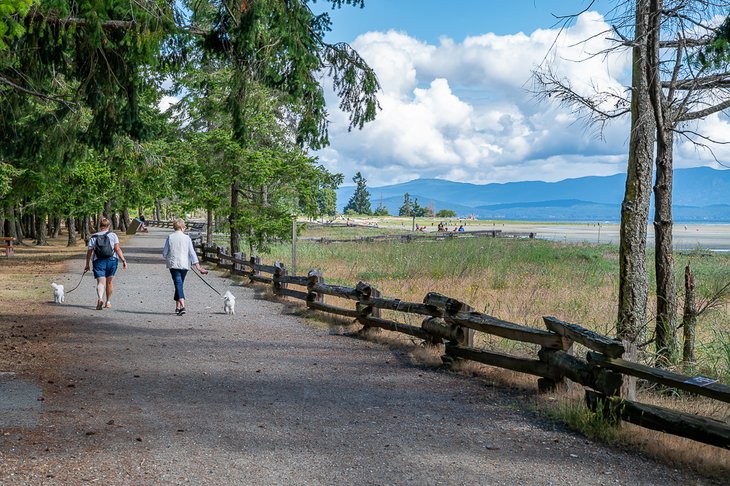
[314,0,730,187]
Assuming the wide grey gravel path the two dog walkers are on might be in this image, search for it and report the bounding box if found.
[0,229,716,485]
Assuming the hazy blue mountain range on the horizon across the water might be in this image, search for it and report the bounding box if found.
[337,167,730,223]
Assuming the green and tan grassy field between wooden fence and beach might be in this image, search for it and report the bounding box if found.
[263,220,730,381]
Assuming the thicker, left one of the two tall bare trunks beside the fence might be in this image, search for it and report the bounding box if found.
[617,0,655,342]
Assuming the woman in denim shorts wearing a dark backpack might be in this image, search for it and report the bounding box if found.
[84,218,127,310]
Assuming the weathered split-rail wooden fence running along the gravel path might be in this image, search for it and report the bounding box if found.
[189,244,730,449]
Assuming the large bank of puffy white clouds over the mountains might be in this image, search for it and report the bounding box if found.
[316,12,730,186]
